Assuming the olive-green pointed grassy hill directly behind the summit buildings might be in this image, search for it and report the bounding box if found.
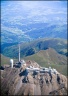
[24,48,67,75]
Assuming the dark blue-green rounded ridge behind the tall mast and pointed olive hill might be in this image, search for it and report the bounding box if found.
[2,38,67,58]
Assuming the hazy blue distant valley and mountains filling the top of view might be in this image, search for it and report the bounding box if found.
[1,1,67,43]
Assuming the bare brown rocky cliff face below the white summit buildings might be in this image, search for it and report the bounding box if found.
[0,60,67,96]
